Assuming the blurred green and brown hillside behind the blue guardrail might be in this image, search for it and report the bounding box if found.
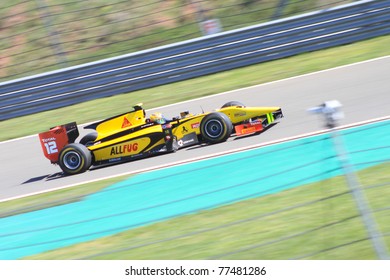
[0,0,352,81]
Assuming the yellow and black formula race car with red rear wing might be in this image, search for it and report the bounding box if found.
[39,101,283,174]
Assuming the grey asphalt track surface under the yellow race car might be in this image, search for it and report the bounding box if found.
[0,56,390,201]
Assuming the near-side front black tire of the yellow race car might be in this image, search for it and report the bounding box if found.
[200,112,233,144]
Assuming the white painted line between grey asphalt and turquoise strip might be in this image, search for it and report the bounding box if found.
[0,115,390,203]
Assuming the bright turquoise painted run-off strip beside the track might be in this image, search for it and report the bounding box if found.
[0,121,390,259]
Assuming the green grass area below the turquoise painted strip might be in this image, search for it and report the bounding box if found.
[16,163,390,259]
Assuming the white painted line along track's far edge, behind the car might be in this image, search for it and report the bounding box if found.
[0,55,390,145]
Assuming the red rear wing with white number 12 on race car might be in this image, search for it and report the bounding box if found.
[38,122,79,163]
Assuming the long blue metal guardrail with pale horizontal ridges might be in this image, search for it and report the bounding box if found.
[0,0,390,121]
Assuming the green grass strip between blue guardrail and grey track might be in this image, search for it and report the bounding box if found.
[0,35,390,141]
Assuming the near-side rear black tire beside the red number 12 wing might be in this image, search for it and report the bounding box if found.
[58,143,92,175]
